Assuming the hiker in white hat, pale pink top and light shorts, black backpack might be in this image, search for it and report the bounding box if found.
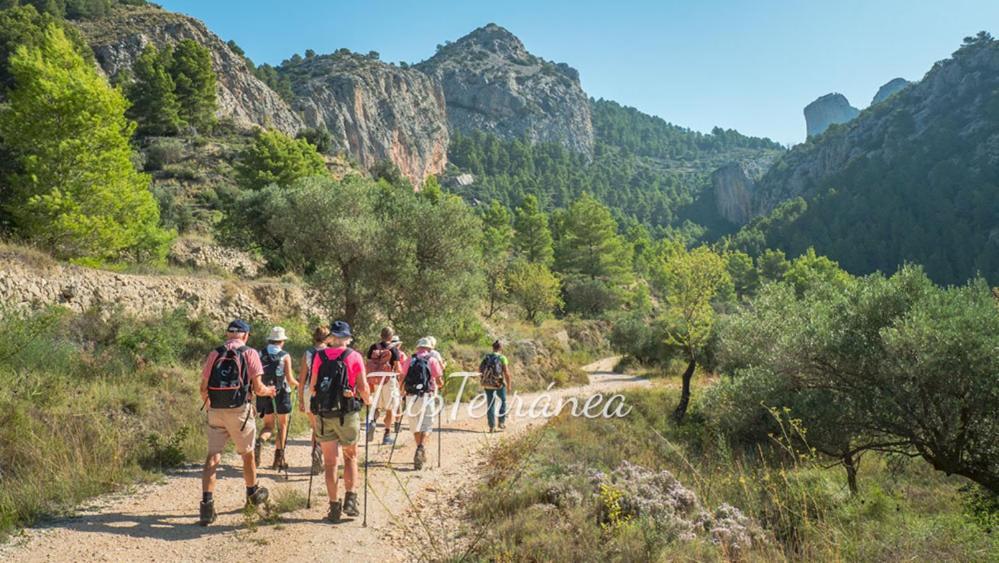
[401,338,444,470]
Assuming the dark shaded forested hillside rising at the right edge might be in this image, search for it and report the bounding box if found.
[740,33,999,282]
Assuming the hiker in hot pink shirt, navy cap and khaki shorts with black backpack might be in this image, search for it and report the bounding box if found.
[312,321,370,523]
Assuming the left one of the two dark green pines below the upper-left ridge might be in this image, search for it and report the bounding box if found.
[128,45,184,135]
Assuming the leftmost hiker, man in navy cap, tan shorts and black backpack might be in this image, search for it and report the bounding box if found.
[198,319,277,526]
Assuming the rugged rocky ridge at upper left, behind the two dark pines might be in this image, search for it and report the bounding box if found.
[77,6,304,135]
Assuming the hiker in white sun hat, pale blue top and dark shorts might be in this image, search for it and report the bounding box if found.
[253,326,298,471]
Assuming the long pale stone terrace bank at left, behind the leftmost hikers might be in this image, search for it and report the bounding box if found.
[0,250,324,323]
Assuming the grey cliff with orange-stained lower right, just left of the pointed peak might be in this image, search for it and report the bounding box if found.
[280,50,449,186]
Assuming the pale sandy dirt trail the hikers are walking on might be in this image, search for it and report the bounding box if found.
[0,358,648,563]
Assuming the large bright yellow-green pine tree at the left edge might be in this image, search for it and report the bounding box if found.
[0,25,170,262]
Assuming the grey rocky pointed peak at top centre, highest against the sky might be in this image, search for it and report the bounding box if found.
[417,24,593,154]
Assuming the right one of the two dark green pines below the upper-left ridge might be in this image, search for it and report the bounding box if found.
[169,39,216,131]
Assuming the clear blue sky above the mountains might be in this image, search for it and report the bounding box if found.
[160,0,999,143]
